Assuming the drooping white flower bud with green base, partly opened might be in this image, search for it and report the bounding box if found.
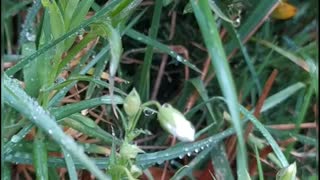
[158,104,195,141]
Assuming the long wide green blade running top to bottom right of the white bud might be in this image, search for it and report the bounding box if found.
[190,0,247,179]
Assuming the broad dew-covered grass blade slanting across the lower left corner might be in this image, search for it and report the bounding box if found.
[3,74,109,179]
